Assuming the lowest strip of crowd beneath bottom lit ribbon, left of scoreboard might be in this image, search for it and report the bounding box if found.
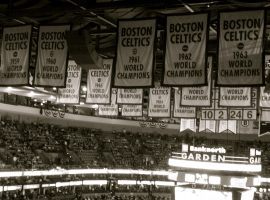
[0,186,171,200]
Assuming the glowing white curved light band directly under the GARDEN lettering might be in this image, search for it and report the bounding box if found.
[168,158,262,172]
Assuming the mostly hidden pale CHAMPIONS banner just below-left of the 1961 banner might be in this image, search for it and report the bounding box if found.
[98,88,118,116]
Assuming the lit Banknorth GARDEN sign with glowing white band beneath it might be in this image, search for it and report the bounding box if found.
[169,144,261,172]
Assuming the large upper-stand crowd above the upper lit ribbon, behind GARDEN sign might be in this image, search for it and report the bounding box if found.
[0,121,270,173]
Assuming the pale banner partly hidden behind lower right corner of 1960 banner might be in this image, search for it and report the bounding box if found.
[57,60,81,104]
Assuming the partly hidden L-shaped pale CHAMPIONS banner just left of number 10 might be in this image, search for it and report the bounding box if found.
[173,88,196,118]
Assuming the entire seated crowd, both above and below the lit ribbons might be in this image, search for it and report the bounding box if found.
[0,120,270,200]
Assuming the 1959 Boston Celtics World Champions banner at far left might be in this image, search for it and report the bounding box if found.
[0,25,32,86]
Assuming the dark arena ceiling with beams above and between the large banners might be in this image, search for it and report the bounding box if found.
[0,0,270,101]
